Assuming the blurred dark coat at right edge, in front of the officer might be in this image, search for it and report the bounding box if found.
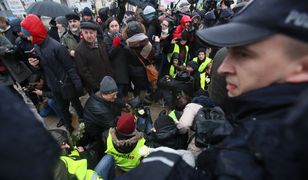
[279,89,308,179]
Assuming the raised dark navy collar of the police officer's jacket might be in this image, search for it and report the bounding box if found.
[230,83,308,120]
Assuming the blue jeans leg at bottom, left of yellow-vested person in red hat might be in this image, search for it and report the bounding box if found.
[94,154,115,180]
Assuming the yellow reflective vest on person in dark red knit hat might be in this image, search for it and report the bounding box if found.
[105,130,145,172]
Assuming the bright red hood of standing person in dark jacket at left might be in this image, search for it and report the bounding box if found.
[21,14,47,44]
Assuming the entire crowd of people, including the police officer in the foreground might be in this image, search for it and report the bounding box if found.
[0,0,308,180]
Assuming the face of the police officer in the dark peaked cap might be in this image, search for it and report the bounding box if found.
[218,35,298,97]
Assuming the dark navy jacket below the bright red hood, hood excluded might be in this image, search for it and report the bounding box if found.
[35,36,83,94]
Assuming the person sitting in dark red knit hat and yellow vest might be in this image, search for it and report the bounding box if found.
[100,113,145,179]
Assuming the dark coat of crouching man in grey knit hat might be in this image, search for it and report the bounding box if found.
[84,92,124,139]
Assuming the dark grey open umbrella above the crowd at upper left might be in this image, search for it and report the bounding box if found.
[26,1,72,17]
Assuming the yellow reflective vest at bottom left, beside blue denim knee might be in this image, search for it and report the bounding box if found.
[60,149,102,180]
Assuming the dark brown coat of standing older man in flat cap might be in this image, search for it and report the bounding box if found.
[75,39,112,92]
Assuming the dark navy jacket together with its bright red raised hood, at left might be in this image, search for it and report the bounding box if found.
[21,15,83,94]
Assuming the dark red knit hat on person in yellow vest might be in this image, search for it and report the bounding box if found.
[117,113,136,134]
